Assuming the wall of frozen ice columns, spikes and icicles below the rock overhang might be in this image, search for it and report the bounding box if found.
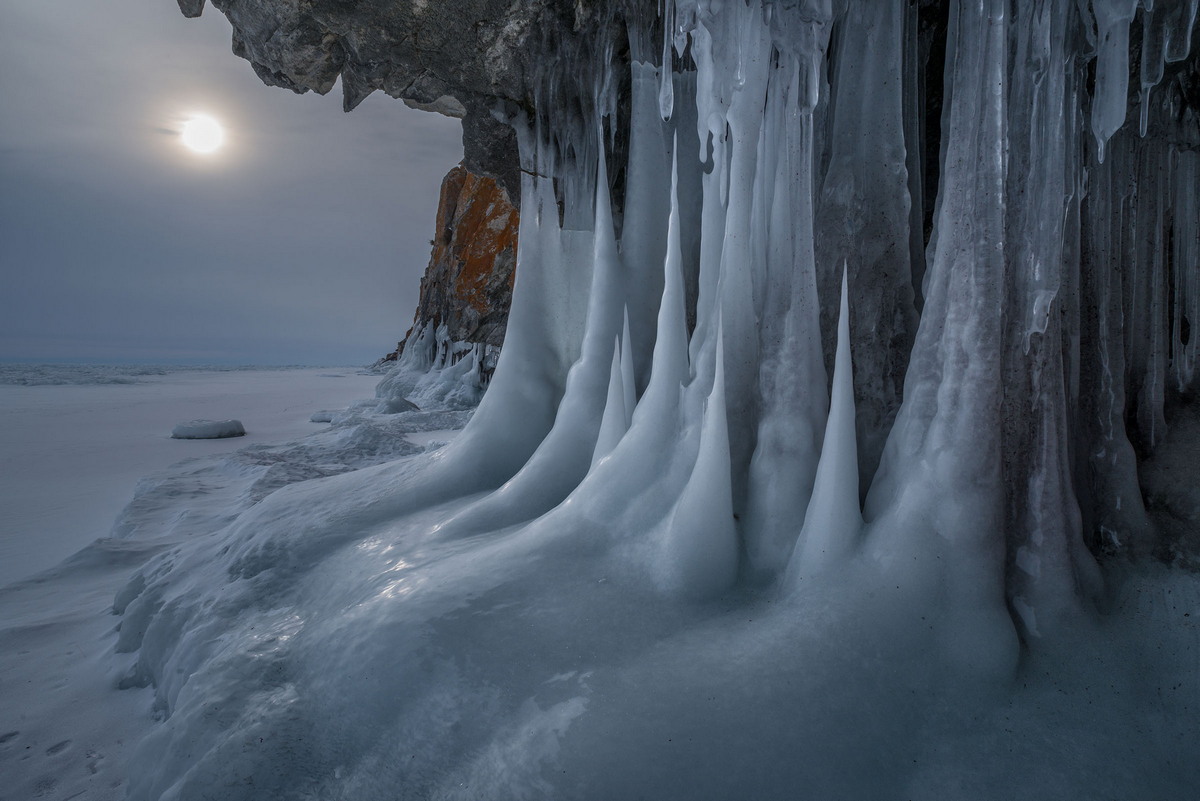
[436,0,1200,639]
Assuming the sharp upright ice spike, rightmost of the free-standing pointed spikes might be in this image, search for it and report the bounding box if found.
[788,267,863,577]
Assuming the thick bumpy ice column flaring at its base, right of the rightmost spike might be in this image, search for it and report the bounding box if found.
[865,0,1016,674]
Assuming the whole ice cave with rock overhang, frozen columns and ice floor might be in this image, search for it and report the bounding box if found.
[37,0,1200,801]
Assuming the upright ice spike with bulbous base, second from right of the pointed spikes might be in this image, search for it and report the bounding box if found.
[665,321,738,598]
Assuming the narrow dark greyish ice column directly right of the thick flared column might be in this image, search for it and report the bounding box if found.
[1001,4,1099,637]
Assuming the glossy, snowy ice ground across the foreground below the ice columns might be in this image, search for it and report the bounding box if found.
[0,362,1200,800]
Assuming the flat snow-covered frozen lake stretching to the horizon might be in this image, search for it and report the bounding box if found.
[0,366,379,586]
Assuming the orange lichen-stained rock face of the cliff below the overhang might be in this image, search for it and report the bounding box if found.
[406,164,520,345]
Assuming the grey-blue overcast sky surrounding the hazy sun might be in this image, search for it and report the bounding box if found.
[0,0,462,365]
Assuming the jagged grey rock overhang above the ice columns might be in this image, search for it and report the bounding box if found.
[192,0,624,198]
